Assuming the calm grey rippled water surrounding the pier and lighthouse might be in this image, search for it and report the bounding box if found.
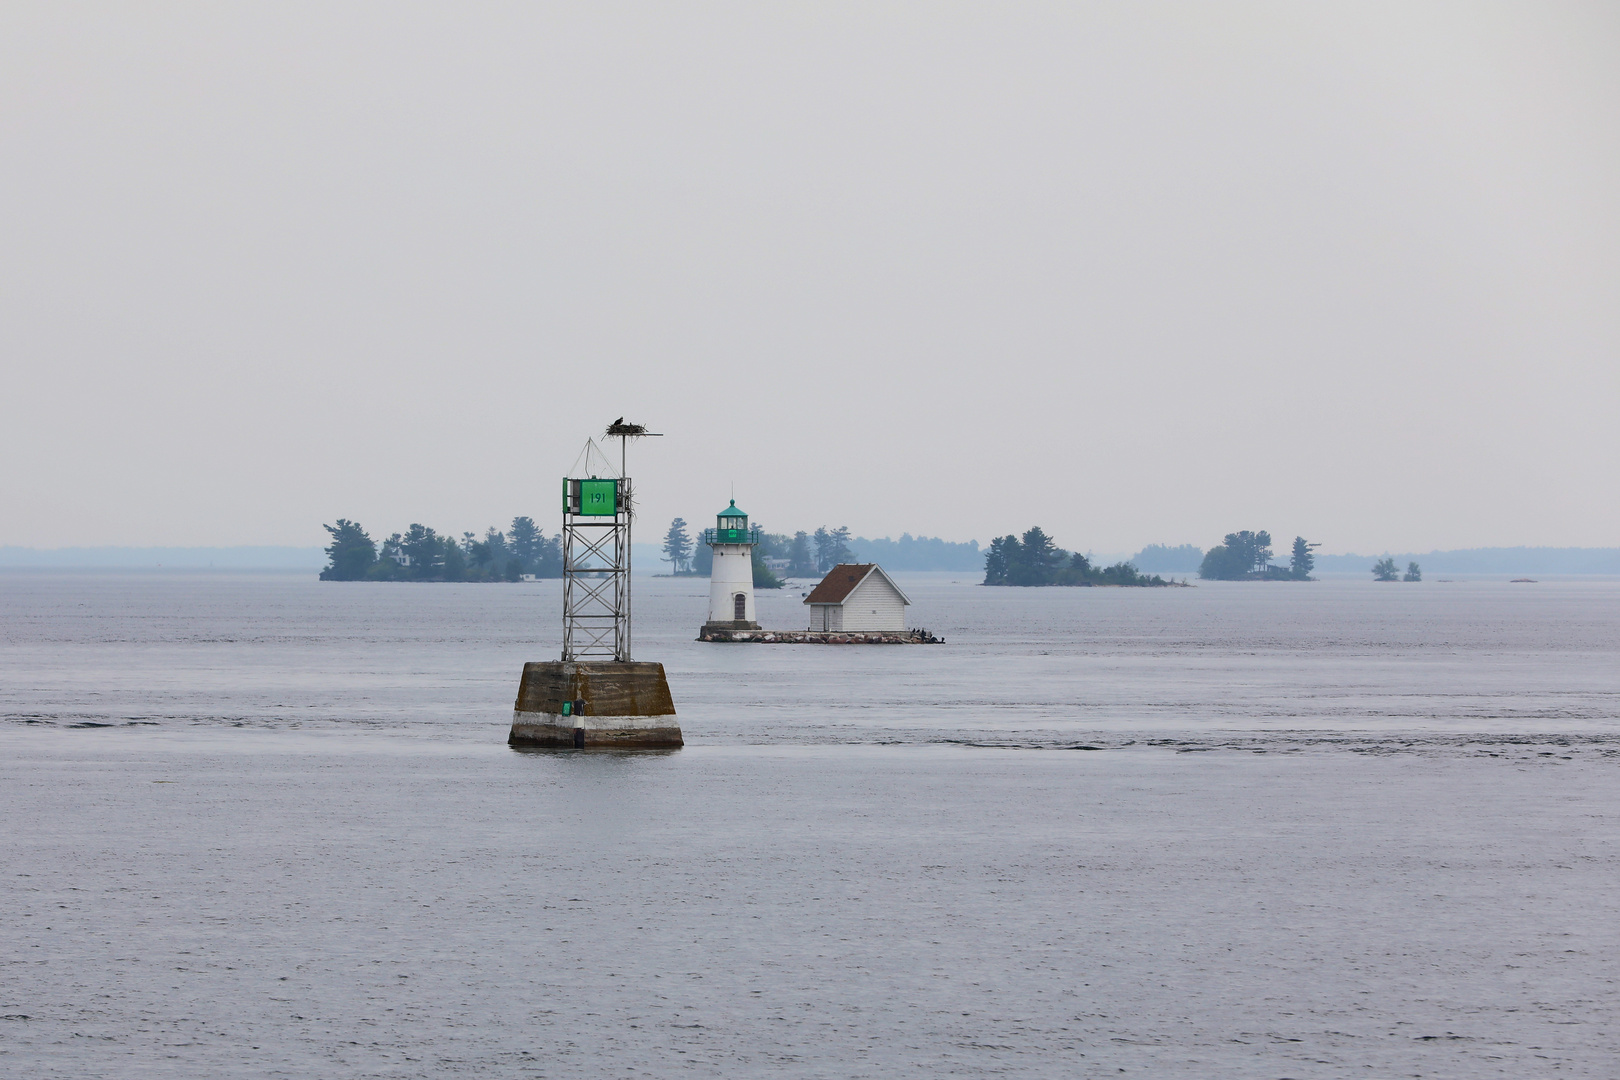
[0,573,1620,1077]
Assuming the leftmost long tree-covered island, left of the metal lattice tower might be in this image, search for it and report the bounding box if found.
[321,517,562,581]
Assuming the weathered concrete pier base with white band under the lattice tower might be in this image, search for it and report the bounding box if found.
[507,661,684,750]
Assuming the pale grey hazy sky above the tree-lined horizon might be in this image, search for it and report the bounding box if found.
[0,0,1620,552]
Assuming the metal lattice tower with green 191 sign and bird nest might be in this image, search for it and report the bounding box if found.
[562,419,654,662]
